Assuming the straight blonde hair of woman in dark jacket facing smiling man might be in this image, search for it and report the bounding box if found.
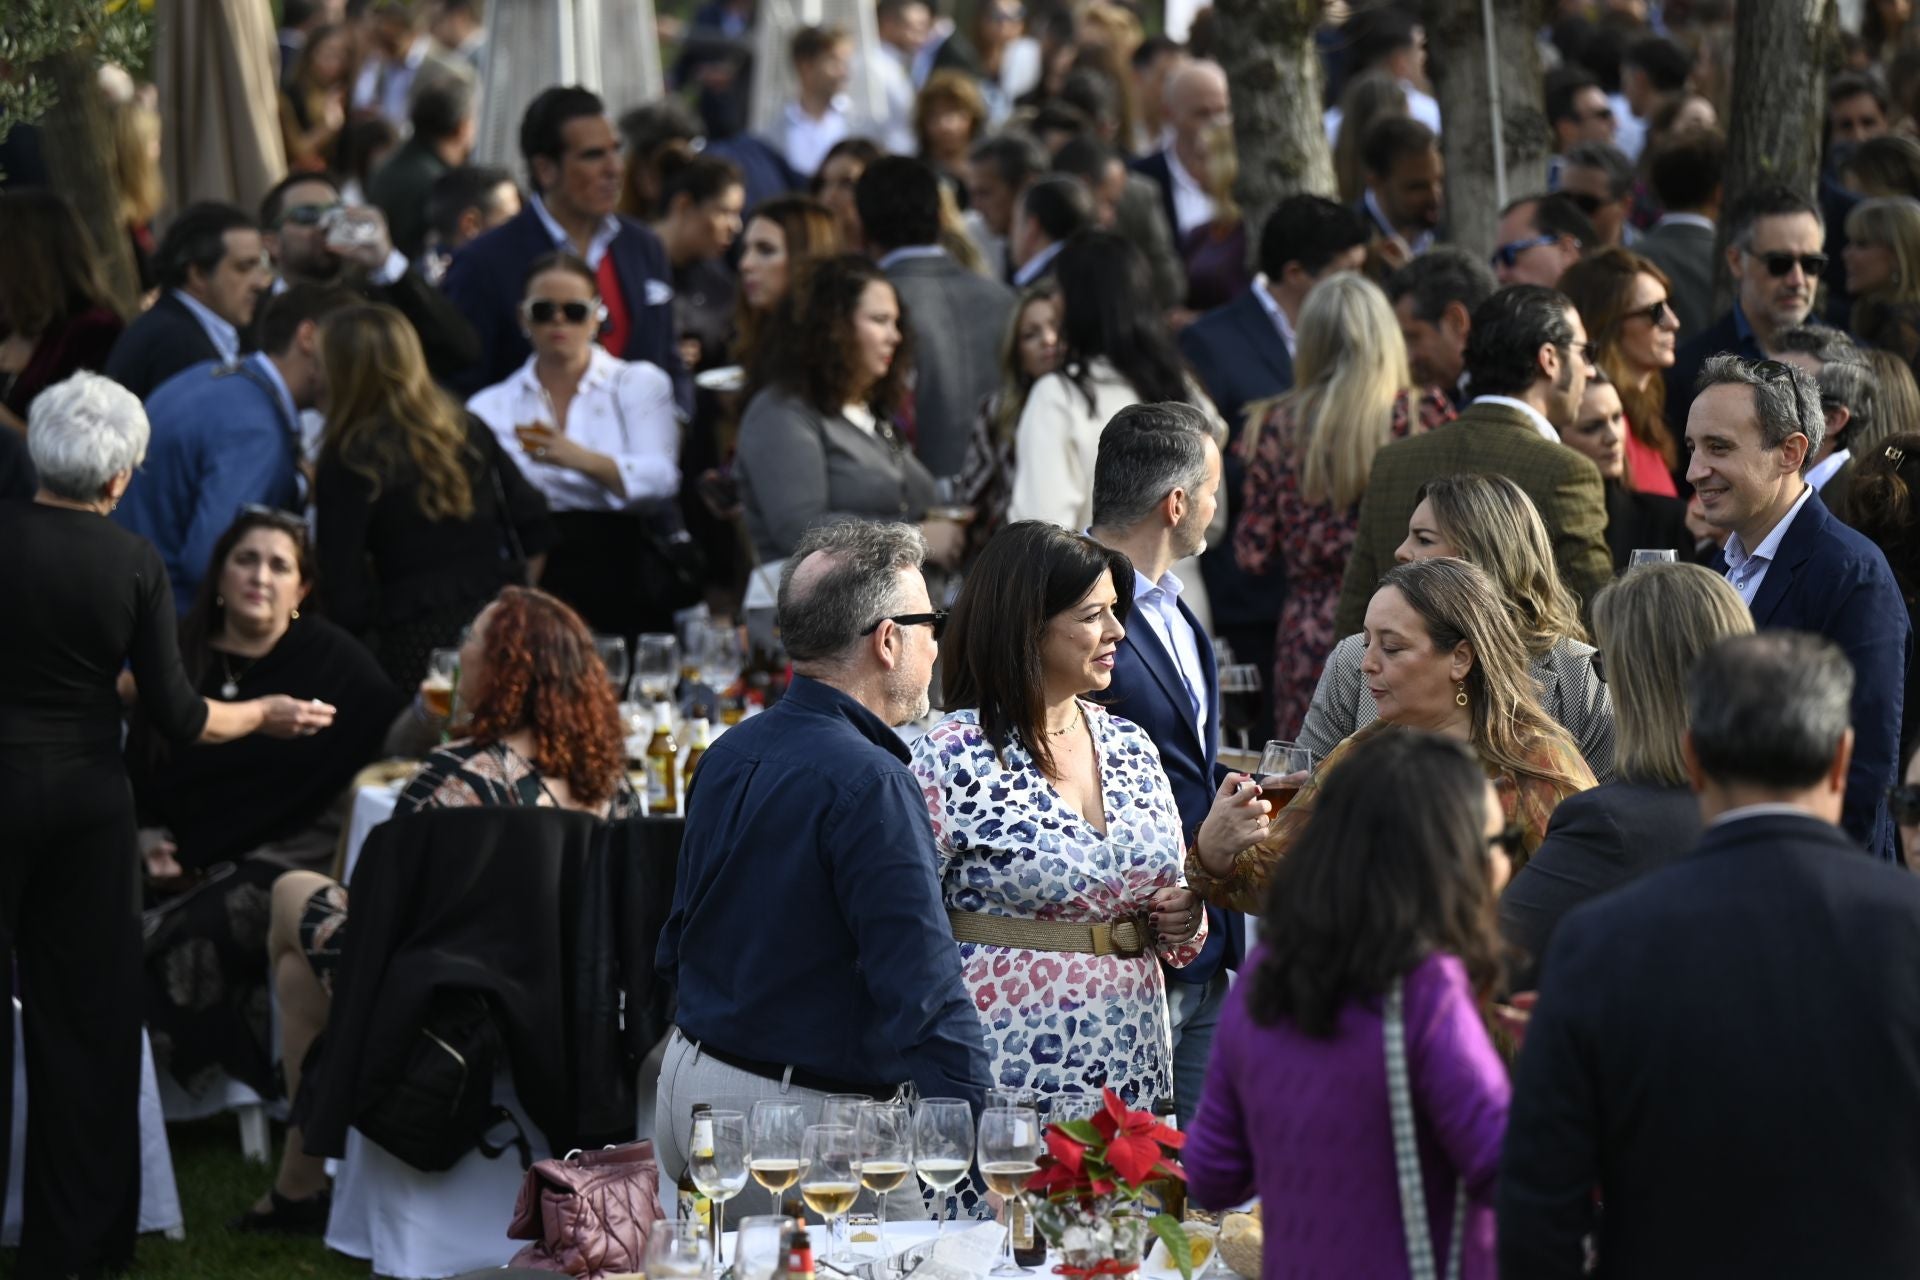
[1594,564,1753,787]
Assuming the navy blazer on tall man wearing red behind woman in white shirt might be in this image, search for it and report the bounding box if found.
[440,203,693,413]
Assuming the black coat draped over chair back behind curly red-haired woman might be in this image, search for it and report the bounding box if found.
[303,808,682,1155]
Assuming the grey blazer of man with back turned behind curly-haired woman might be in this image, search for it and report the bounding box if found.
[887,253,1014,476]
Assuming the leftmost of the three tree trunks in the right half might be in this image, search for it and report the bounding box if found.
[1213,0,1334,255]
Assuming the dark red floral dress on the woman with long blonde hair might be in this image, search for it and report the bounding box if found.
[1233,388,1453,737]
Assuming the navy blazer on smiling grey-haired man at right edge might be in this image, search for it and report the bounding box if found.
[1713,493,1912,862]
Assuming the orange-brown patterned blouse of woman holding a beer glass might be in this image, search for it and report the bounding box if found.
[1187,722,1597,913]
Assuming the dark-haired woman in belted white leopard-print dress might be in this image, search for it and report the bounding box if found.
[912,520,1263,1107]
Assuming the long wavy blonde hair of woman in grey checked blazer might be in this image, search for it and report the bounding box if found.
[1415,476,1586,658]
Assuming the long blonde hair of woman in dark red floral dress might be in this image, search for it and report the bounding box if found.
[1269,271,1413,510]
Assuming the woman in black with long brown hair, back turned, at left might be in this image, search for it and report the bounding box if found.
[313,303,553,689]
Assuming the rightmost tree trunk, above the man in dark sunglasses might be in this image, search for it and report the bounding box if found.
[1713,0,1839,313]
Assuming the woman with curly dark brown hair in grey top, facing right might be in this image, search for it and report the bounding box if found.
[733,255,966,576]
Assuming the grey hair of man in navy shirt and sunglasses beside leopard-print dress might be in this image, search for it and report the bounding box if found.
[776,520,927,664]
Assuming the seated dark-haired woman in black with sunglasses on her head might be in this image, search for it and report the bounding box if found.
[127,510,415,1098]
